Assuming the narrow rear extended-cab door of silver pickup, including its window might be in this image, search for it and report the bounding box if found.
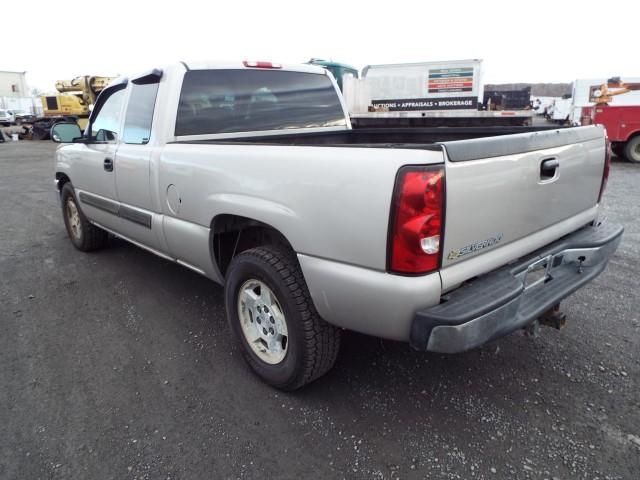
[115,77,163,250]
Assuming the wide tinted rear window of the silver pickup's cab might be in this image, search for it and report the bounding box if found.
[175,70,346,136]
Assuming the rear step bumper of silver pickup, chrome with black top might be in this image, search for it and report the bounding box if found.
[410,225,623,353]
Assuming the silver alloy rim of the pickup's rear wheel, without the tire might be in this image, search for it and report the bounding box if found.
[238,279,289,365]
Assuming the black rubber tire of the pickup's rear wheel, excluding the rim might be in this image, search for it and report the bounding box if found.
[225,246,341,390]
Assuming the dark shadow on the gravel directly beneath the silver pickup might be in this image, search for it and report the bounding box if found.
[101,234,580,414]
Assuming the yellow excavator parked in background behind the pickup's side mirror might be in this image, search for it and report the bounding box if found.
[31,75,114,140]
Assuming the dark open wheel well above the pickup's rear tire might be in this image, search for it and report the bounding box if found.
[211,214,293,276]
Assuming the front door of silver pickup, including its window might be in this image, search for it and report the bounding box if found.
[69,84,126,230]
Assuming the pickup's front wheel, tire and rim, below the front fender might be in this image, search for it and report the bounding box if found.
[60,182,109,252]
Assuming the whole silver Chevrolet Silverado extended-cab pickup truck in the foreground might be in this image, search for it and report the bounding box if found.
[52,62,622,390]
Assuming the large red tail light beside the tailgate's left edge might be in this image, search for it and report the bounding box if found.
[388,166,445,274]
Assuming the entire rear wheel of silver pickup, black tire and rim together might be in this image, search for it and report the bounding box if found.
[225,246,340,390]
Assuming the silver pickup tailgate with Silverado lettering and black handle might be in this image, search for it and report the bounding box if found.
[441,126,606,289]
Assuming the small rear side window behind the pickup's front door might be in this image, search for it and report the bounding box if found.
[122,83,159,145]
